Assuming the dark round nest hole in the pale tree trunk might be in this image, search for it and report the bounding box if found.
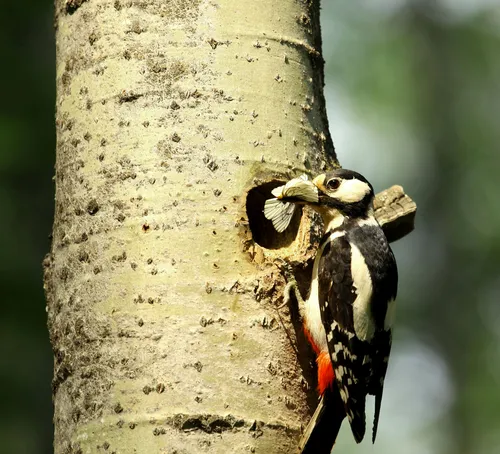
[246,180,302,249]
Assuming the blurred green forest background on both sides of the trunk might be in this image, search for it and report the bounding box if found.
[0,0,500,454]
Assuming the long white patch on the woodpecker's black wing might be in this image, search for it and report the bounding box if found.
[351,244,375,341]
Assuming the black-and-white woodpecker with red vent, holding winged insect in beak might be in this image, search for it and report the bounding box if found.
[264,169,398,453]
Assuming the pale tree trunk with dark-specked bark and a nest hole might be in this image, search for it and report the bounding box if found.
[44,0,335,453]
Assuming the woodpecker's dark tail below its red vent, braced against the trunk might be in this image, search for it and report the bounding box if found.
[299,386,345,454]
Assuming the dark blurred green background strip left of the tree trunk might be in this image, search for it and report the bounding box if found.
[0,0,55,454]
